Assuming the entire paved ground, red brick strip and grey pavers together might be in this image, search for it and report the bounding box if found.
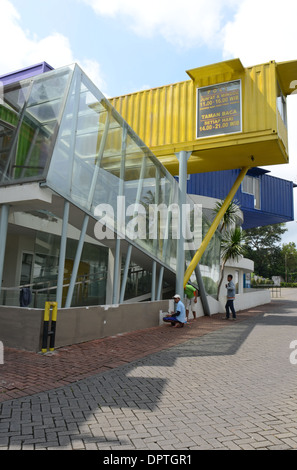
[0,290,297,450]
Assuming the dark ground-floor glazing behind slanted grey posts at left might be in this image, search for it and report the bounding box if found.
[0,207,108,308]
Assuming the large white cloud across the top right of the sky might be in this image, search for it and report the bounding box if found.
[81,0,297,237]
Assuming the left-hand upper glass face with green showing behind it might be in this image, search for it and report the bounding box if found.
[0,67,72,184]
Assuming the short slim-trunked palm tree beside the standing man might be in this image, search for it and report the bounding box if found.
[217,227,244,300]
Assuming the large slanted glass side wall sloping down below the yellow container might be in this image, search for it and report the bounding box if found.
[47,66,221,276]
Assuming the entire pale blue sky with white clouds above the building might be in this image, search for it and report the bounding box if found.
[0,0,297,244]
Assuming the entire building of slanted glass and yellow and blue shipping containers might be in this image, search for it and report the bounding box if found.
[0,59,296,318]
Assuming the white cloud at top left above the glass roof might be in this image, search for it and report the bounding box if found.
[0,0,105,91]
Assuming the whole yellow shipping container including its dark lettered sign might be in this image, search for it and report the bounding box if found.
[110,59,297,175]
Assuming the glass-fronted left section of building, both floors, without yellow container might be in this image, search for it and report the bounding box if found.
[0,65,220,308]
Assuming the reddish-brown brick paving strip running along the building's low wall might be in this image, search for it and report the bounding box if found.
[0,306,265,402]
